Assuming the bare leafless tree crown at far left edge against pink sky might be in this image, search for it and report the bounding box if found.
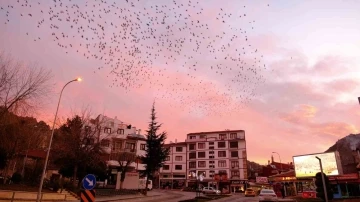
[0,53,51,119]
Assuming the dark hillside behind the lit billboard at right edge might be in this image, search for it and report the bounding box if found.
[325,134,360,174]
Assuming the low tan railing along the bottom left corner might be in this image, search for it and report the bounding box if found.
[0,191,67,202]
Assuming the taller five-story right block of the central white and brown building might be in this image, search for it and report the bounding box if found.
[185,130,247,192]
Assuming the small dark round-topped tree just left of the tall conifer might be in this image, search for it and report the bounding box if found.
[111,152,137,189]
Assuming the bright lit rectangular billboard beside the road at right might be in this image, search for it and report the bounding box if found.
[293,152,342,178]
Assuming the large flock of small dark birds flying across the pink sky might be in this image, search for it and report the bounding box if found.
[0,0,269,115]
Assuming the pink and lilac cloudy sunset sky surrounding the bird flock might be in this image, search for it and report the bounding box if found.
[0,0,360,164]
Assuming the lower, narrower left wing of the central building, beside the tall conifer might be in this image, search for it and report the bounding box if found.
[159,142,187,189]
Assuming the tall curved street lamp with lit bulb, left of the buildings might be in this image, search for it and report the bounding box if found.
[36,77,82,202]
